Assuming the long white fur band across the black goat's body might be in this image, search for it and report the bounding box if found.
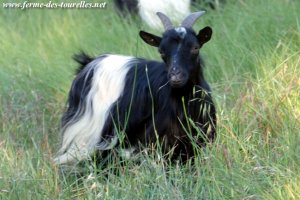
[54,55,133,164]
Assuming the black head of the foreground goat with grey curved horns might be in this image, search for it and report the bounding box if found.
[140,11,212,88]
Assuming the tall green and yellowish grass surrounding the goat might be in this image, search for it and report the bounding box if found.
[0,0,300,200]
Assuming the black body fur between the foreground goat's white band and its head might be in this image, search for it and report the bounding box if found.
[103,59,216,161]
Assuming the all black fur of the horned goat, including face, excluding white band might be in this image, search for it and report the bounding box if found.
[62,24,217,164]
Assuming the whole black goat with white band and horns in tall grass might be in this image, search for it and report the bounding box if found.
[55,12,216,164]
